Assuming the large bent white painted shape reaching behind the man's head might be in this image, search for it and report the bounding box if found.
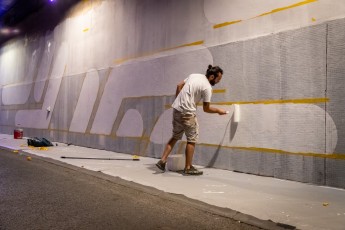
[91,49,212,134]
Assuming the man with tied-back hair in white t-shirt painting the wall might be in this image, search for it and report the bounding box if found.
[156,65,227,175]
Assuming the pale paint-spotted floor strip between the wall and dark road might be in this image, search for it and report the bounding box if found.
[0,134,345,230]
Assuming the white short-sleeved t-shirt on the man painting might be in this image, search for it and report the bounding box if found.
[172,74,212,114]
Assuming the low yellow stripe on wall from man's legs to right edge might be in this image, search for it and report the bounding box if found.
[199,143,345,160]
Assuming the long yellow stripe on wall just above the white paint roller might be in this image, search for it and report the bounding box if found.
[211,98,329,105]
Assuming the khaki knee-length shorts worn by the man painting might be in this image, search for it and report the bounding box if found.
[173,109,199,143]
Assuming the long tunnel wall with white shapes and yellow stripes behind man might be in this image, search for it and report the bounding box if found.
[0,0,345,188]
